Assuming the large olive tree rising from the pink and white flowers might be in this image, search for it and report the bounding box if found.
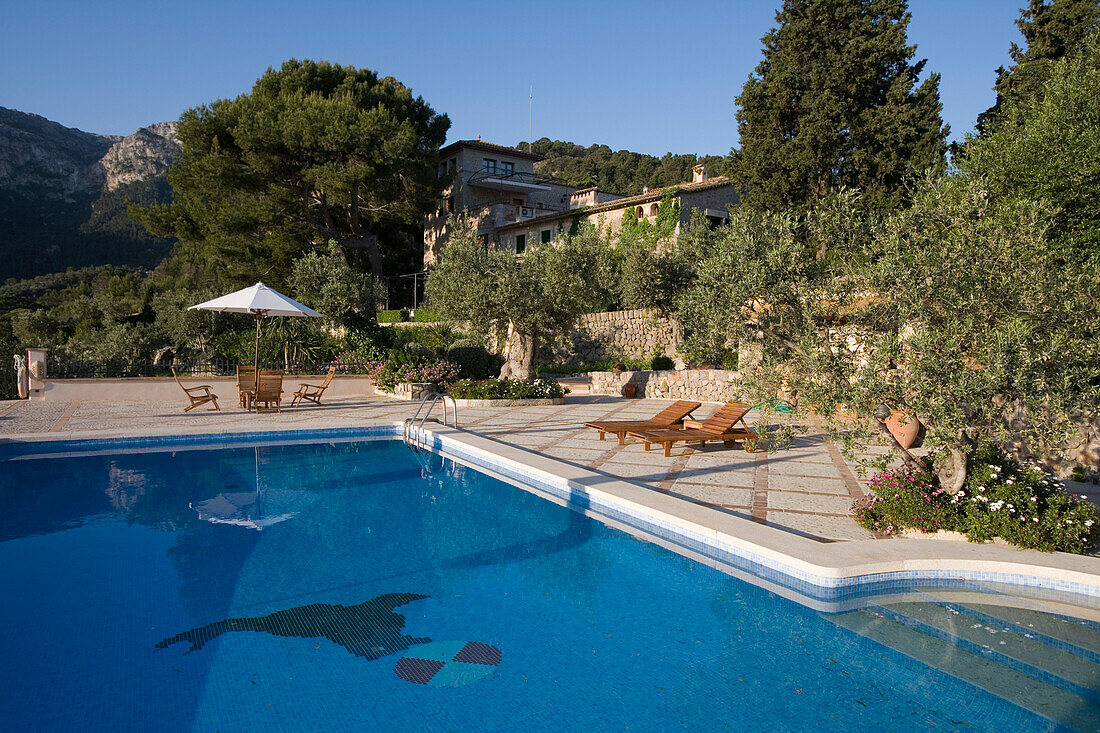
[862,176,1100,491]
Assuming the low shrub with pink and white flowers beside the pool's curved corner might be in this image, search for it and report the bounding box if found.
[853,446,1100,553]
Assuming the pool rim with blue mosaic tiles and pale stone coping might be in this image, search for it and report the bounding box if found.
[0,425,1100,608]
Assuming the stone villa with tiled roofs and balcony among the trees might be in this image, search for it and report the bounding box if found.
[424,140,740,266]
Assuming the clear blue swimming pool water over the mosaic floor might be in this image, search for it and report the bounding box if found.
[0,441,1095,731]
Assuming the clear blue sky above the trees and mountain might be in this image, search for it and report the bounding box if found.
[0,0,1026,155]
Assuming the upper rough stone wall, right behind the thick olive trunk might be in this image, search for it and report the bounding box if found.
[540,308,680,362]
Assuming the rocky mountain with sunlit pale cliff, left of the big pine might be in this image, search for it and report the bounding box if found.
[0,107,179,281]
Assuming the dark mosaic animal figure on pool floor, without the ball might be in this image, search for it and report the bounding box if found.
[156,593,431,659]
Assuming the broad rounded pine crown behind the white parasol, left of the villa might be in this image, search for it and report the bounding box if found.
[131,59,450,287]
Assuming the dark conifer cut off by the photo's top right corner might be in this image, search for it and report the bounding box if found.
[978,0,1100,135]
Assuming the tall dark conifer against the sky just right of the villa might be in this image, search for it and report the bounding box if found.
[734,0,947,210]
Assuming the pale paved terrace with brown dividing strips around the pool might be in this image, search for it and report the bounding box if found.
[0,396,902,540]
